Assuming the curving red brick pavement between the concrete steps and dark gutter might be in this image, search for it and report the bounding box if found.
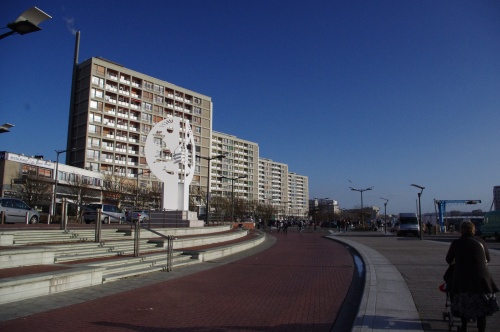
[0,232,354,331]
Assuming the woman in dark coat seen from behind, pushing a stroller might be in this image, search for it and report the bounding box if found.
[446,221,498,332]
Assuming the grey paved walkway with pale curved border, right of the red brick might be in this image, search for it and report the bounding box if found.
[330,231,500,332]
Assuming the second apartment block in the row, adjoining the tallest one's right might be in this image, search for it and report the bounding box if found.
[210,131,259,201]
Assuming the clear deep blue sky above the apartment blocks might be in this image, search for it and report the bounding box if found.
[0,0,500,213]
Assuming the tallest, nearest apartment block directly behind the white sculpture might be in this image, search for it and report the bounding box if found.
[66,58,212,205]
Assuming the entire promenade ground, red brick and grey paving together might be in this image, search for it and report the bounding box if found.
[0,229,500,331]
